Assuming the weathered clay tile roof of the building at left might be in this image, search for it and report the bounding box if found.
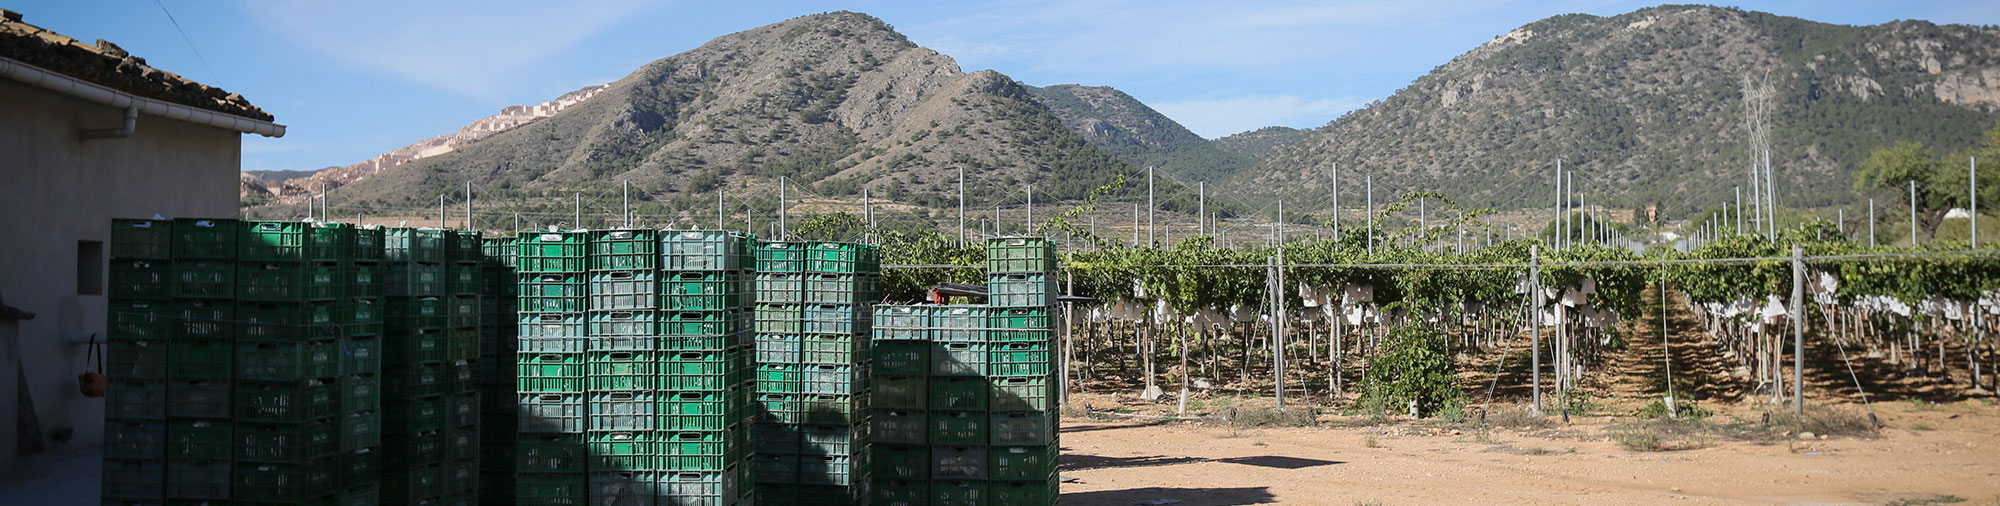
[0,10,272,122]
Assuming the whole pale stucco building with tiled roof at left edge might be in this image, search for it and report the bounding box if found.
[0,10,284,474]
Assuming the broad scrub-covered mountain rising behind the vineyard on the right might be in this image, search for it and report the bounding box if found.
[1236,6,2000,218]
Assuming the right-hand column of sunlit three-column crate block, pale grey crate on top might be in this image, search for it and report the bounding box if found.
[656,230,756,504]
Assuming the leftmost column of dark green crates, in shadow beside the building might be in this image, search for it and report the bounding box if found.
[104,220,179,506]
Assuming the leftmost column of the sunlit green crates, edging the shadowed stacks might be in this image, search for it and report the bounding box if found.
[512,230,590,506]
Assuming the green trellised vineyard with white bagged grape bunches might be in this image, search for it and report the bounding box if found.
[844,198,2000,424]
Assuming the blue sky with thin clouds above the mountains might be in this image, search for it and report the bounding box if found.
[0,0,2000,170]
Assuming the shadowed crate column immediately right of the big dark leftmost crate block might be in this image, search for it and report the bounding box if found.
[382,228,456,504]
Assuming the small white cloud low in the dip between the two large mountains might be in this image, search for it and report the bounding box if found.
[1152,94,1368,138]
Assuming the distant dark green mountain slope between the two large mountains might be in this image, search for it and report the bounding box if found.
[1028,84,1258,182]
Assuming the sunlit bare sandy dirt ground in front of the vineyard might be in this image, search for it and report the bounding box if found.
[1062,400,2000,506]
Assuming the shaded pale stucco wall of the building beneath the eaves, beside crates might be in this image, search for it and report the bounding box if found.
[0,78,242,470]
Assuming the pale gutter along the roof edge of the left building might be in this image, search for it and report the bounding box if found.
[0,56,284,138]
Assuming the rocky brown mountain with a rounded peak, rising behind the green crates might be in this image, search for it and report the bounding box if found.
[252,12,1178,223]
